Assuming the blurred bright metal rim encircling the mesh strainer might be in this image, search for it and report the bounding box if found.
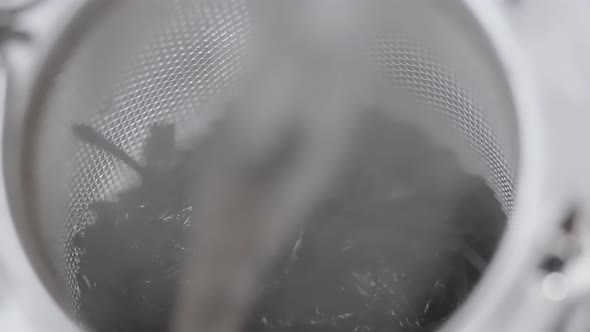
[0,0,588,332]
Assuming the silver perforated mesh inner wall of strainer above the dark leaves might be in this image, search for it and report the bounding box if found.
[16,0,519,330]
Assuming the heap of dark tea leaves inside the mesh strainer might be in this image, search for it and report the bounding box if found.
[74,107,506,332]
